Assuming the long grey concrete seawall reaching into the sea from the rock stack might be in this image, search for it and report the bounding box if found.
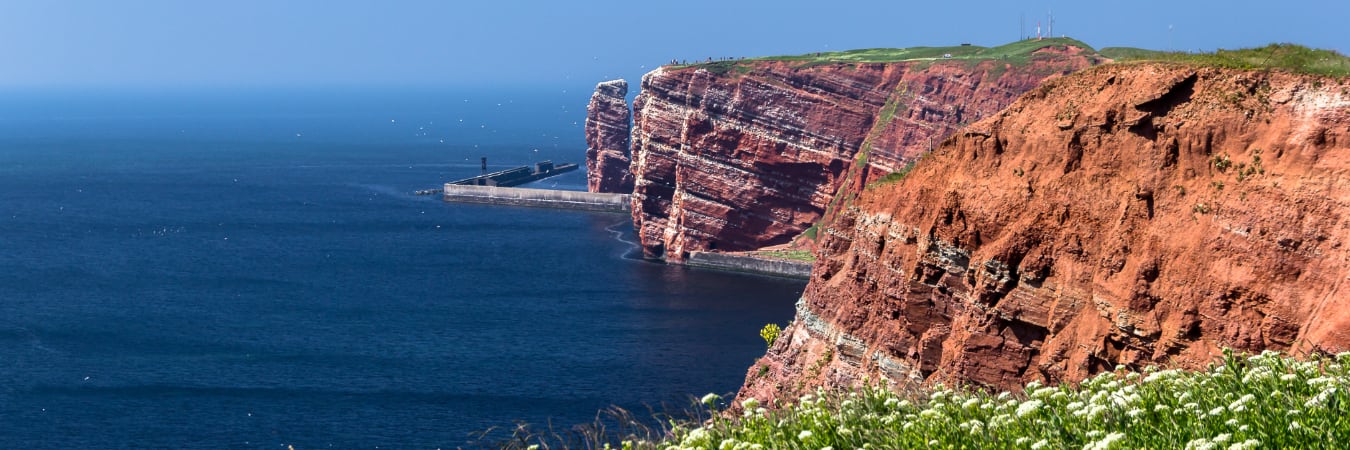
[444,184,632,212]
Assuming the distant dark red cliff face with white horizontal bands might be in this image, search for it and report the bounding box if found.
[632,47,1094,261]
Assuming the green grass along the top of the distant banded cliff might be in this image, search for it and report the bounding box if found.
[671,38,1094,74]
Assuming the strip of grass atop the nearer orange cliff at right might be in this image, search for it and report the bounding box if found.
[1100,43,1350,77]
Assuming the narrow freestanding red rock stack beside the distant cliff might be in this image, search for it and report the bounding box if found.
[586,80,633,193]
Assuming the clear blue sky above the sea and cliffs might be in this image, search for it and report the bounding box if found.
[0,0,1350,88]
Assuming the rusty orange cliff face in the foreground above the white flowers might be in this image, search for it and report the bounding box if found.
[741,65,1350,400]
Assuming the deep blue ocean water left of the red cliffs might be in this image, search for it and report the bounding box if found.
[0,89,803,449]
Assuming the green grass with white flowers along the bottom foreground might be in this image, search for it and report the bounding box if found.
[564,351,1350,450]
